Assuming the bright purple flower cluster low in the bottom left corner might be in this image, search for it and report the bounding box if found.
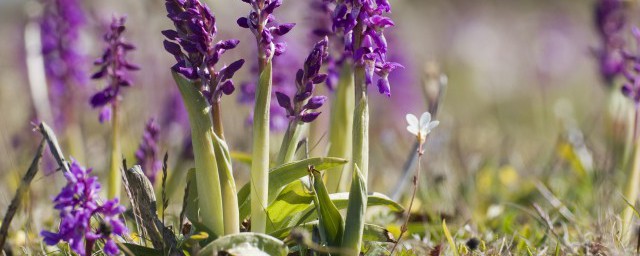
[40,161,128,255]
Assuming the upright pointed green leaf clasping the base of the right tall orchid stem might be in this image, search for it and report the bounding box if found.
[342,164,367,255]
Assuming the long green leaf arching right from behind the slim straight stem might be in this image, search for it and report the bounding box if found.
[238,157,347,221]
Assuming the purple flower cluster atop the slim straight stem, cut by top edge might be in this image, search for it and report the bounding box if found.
[237,0,295,60]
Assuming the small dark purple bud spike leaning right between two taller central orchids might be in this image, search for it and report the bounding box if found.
[276,37,329,123]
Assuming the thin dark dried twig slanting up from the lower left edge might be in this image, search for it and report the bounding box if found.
[0,139,45,250]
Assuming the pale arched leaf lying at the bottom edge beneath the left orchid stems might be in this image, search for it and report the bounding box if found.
[198,232,289,256]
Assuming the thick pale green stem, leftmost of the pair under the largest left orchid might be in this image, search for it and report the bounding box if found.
[173,73,225,236]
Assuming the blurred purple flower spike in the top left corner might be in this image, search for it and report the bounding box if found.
[39,0,88,125]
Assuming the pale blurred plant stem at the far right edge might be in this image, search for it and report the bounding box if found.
[622,108,640,242]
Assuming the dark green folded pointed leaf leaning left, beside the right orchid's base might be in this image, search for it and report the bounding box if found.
[311,168,344,247]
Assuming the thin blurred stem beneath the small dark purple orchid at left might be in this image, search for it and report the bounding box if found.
[107,102,122,199]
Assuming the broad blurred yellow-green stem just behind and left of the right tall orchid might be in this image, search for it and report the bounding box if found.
[325,63,355,193]
